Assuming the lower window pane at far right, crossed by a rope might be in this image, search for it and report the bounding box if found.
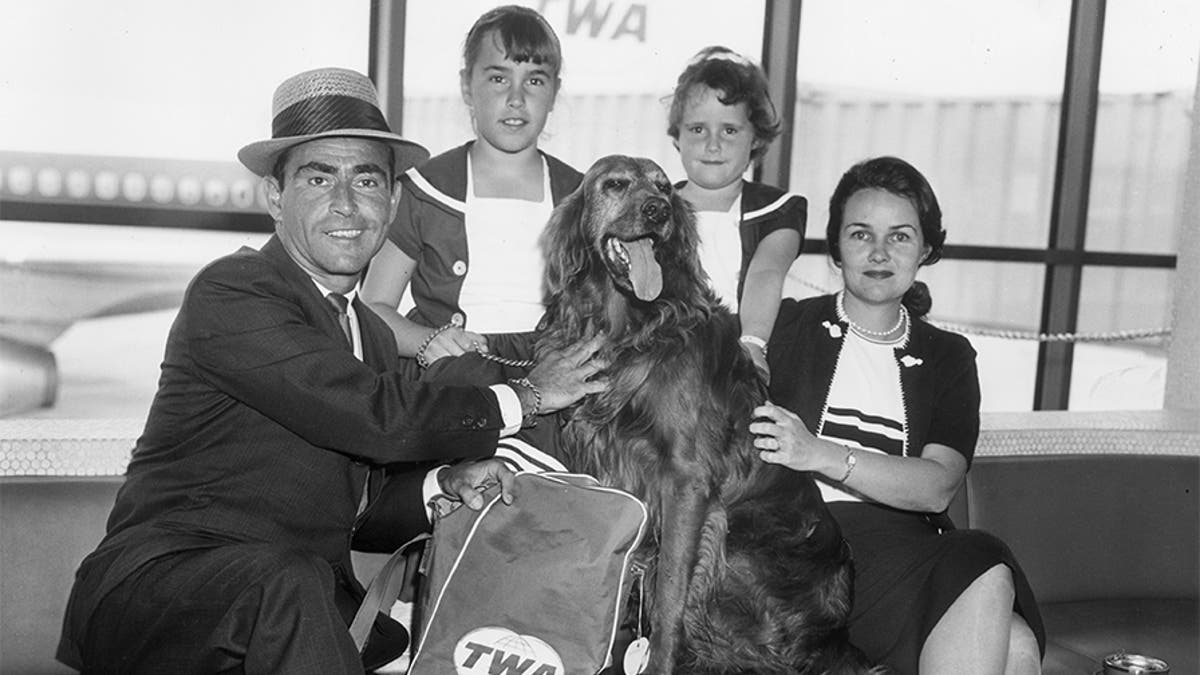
[1069,267,1175,410]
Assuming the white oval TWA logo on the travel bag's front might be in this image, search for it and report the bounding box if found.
[454,626,566,675]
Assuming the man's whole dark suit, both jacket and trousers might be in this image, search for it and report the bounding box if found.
[59,238,503,671]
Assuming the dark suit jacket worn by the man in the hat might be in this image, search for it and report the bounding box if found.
[60,238,504,663]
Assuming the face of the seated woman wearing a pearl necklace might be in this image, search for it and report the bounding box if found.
[838,187,930,305]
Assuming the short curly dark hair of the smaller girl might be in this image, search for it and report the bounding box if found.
[667,47,782,160]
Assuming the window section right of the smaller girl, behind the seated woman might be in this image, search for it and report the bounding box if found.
[775,0,1200,411]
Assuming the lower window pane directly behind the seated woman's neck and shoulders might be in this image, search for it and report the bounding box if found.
[784,253,1044,412]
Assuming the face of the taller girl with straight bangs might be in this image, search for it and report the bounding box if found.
[462,31,558,153]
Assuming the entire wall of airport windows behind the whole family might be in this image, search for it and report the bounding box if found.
[0,0,1200,416]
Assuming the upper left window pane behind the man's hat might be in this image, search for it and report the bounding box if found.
[0,0,371,162]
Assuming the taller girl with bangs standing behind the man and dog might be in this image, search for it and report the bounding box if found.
[362,5,582,368]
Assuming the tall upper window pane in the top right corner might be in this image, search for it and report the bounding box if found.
[1087,0,1200,253]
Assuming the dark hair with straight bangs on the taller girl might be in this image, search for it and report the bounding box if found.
[462,5,563,84]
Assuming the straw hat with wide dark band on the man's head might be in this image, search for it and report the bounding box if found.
[238,68,430,175]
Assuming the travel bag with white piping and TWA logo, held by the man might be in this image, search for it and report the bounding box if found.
[409,472,647,675]
